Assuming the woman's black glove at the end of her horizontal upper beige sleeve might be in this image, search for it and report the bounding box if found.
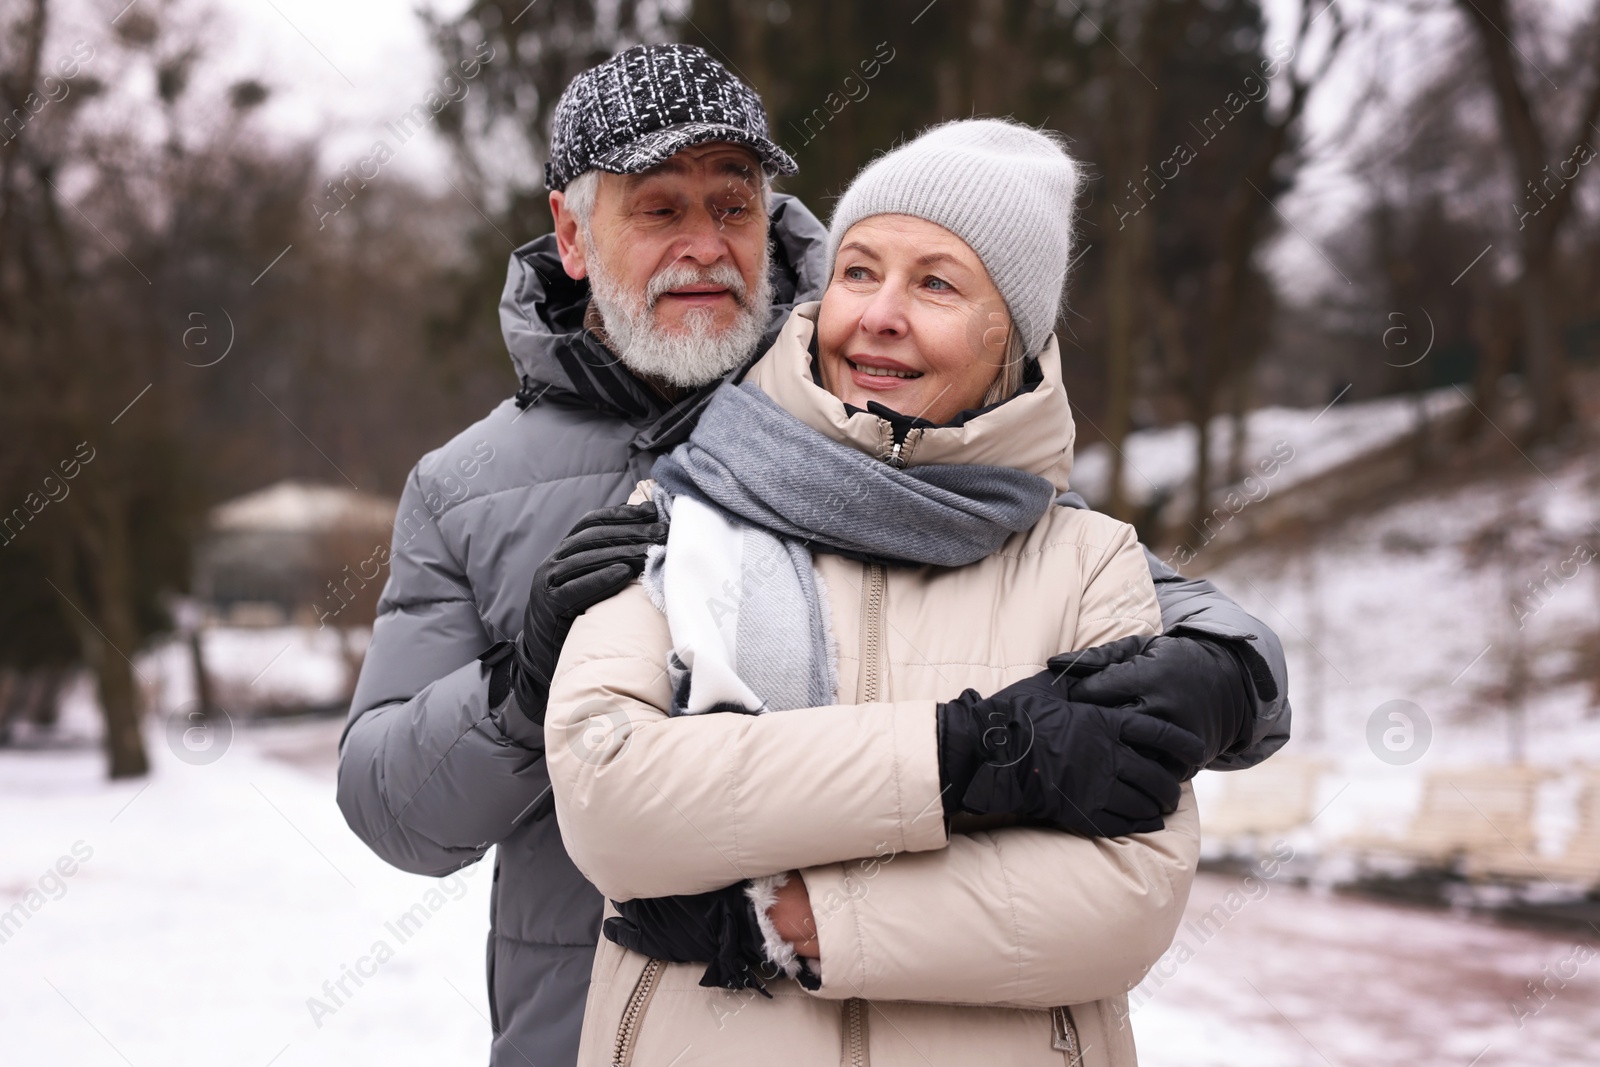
[938,670,1200,837]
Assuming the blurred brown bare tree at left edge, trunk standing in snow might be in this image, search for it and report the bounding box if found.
[0,0,284,777]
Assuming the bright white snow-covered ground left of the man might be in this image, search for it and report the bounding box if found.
[0,721,491,1067]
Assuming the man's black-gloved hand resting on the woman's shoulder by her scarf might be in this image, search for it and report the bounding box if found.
[478,501,667,726]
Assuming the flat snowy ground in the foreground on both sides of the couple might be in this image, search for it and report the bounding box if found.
[0,723,1600,1067]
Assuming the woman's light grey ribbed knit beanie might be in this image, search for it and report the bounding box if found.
[827,118,1080,357]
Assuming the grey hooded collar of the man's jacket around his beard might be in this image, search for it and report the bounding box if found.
[499,195,827,451]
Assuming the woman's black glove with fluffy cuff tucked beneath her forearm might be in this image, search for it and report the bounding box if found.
[605,881,782,997]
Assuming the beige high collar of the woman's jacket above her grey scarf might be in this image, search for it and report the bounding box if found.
[746,301,1077,493]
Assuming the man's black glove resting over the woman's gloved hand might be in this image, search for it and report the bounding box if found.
[1050,633,1256,781]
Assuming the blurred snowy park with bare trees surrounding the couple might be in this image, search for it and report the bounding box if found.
[0,0,1600,1067]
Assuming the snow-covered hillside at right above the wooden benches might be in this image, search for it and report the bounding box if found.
[1197,435,1600,876]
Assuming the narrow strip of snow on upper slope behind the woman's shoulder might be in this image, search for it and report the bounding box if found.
[1072,387,1466,504]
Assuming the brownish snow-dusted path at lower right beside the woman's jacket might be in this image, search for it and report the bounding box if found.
[1130,861,1600,1067]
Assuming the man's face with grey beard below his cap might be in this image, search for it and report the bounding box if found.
[550,142,766,347]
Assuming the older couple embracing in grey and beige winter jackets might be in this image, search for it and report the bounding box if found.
[339,45,1288,1067]
